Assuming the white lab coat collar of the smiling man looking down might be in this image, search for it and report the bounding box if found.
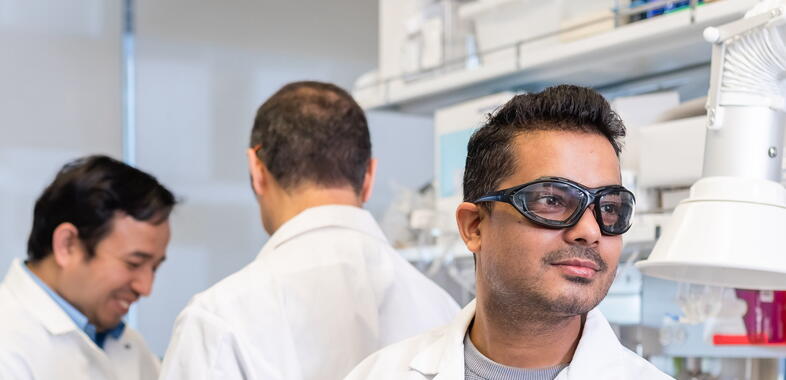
[3,259,79,335]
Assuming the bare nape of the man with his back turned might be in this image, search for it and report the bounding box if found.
[264,186,362,234]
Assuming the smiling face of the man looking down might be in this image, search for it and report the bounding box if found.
[61,214,170,331]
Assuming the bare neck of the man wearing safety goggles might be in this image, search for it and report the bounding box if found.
[470,303,585,368]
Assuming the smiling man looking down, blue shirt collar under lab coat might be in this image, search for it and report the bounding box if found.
[0,156,175,380]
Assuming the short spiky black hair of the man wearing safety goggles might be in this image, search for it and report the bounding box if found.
[464,85,625,211]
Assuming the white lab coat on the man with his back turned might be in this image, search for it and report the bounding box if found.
[161,205,459,380]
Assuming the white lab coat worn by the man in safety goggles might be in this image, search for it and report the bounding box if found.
[345,301,671,380]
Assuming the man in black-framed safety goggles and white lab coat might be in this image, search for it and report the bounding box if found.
[348,85,670,380]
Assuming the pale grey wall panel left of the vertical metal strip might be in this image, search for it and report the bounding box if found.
[0,0,122,275]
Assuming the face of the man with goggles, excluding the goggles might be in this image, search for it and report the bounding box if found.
[476,131,622,317]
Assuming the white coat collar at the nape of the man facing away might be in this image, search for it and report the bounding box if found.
[265,205,387,249]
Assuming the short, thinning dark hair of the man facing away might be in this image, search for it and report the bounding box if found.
[250,82,371,194]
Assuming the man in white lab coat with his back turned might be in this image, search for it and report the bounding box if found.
[161,82,458,380]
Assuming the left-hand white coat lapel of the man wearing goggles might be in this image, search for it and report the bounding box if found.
[409,300,475,380]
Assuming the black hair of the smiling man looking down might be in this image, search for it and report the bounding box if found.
[27,155,176,262]
